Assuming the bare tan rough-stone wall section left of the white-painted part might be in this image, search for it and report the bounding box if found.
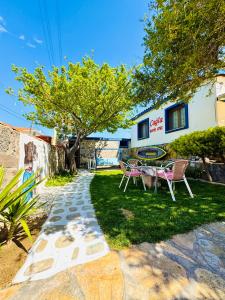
[0,124,20,184]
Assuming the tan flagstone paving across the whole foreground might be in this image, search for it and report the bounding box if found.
[0,222,225,300]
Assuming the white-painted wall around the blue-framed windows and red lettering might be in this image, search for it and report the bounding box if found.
[131,84,217,148]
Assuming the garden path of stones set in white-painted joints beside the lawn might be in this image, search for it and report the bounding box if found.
[13,171,109,283]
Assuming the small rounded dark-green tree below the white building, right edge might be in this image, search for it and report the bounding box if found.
[169,127,225,181]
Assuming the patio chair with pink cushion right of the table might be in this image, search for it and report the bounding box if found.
[155,159,194,201]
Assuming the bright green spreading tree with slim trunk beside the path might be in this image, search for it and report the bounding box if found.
[8,57,135,172]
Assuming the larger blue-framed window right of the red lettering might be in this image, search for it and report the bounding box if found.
[165,103,188,132]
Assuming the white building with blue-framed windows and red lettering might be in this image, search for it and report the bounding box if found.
[131,75,225,148]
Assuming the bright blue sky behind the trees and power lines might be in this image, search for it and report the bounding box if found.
[0,0,148,137]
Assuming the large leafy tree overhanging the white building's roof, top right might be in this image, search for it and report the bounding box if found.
[135,0,225,105]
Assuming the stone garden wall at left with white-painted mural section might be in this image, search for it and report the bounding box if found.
[0,124,65,185]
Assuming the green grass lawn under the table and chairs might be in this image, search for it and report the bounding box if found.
[91,171,225,249]
